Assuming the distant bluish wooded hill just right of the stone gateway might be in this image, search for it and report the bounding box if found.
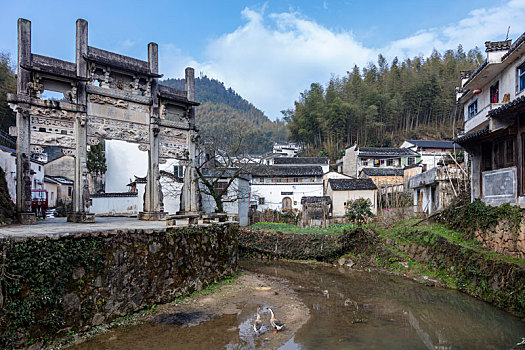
[162,76,287,154]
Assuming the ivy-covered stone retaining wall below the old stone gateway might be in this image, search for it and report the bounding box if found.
[0,224,238,348]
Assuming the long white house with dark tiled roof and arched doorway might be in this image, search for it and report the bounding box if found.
[251,165,324,211]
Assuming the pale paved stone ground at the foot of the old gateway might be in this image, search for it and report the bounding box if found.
[0,217,166,239]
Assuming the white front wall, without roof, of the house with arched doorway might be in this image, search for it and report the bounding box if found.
[251,182,323,210]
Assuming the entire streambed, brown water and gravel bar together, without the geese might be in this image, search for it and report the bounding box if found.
[57,260,525,350]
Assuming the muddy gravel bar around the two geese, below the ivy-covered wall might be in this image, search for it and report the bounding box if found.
[70,272,309,350]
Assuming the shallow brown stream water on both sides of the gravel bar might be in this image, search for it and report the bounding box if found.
[70,261,525,350]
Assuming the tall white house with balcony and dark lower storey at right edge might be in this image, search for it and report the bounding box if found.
[456,33,525,207]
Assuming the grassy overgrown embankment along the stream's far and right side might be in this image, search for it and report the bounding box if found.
[239,229,525,318]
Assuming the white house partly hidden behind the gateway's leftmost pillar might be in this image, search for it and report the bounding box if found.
[0,145,44,202]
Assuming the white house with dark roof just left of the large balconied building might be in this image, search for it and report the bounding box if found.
[401,140,462,171]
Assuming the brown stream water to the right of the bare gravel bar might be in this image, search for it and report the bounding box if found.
[244,261,525,349]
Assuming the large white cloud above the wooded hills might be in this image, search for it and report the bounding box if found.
[160,0,525,119]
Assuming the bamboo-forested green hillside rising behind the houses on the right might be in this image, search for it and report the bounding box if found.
[285,46,483,159]
